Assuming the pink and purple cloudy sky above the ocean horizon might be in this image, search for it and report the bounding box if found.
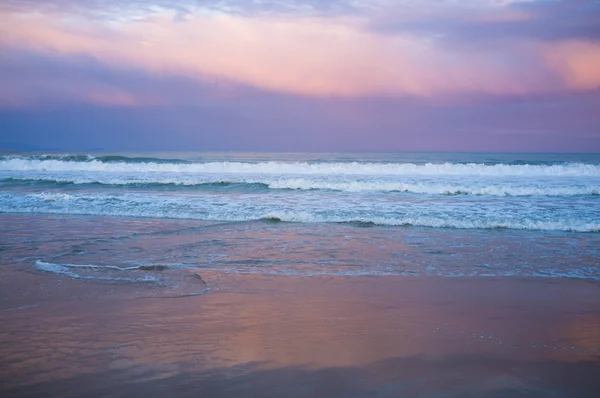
[0,0,600,152]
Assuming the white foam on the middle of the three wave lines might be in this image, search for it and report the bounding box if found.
[4,172,600,197]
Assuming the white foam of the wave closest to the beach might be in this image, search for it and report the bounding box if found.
[0,193,600,232]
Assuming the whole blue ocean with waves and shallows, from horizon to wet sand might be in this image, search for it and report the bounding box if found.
[0,152,600,286]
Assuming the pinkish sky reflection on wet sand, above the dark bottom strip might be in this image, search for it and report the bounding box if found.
[0,272,600,390]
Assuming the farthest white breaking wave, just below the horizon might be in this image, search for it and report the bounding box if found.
[0,157,600,177]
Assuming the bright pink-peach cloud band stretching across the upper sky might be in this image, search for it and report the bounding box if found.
[0,6,600,101]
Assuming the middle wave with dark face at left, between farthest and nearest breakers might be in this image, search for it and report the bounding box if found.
[0,175,600,196]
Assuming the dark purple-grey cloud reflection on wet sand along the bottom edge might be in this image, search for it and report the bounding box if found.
[8,356,600,398]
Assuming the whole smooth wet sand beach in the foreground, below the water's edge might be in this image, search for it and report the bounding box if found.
[0,265,600,398]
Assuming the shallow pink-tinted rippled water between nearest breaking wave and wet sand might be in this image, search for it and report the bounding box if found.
[0,215,600,284]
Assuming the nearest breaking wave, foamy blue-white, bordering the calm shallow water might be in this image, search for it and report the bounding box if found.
[0,193,600,232]
